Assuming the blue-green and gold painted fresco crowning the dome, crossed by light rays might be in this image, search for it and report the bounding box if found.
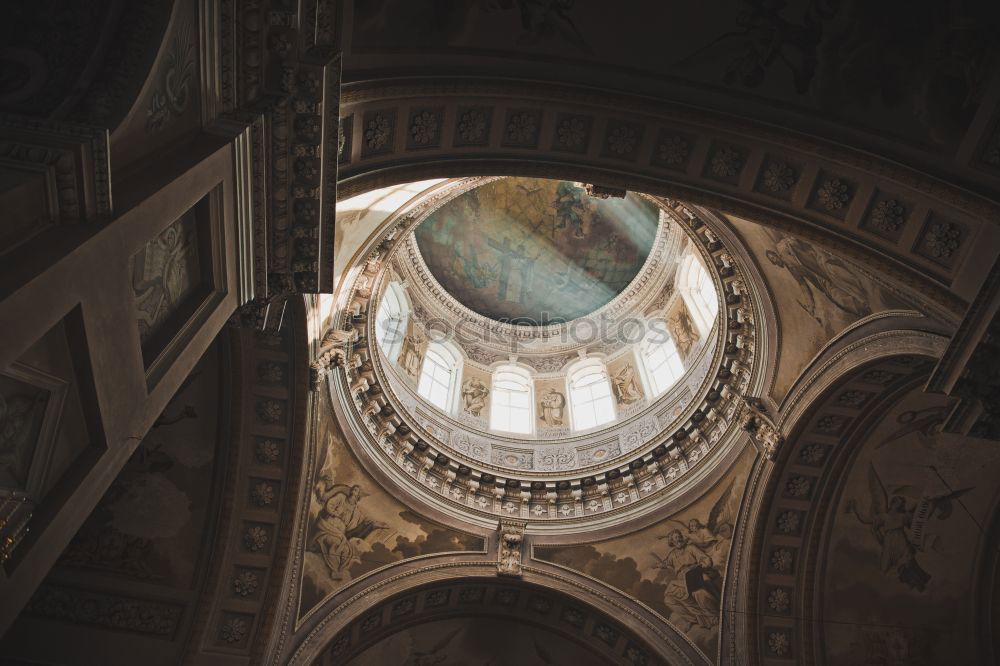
[416,178,659,325]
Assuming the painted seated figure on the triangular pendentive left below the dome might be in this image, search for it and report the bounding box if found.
[312,470,389,580]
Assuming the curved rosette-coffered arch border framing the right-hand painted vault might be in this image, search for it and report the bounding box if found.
[722,330,947,666]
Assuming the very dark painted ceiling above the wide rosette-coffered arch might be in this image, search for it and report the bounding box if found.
[352,0,1000,149]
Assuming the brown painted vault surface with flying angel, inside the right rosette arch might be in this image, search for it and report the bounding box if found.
[818,388,1000,666]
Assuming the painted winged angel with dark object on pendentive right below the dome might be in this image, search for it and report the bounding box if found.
[653,482,734,631]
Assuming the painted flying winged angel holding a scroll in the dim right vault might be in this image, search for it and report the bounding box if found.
[844,464,972,592]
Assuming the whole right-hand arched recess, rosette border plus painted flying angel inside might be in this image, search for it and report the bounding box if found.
[722,331,1000,664]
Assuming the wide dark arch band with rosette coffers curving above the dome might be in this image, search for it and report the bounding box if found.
[341,79,1000,316]
